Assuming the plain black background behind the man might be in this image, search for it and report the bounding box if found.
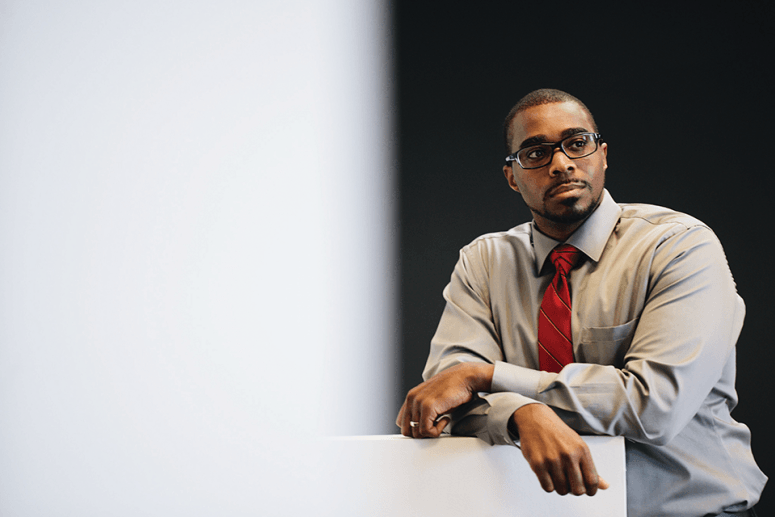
[393,0,775,516]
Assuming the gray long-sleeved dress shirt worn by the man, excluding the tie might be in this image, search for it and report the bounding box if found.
[423,191,767,517]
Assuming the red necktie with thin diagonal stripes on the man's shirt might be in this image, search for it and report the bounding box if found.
[538,244,581,372]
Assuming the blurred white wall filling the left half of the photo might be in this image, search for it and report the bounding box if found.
[0,0,397,517]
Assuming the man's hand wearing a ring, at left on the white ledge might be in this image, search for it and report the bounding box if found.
[396,363,495,438]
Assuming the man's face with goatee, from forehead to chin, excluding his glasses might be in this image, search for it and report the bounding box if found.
[503,102,608,240]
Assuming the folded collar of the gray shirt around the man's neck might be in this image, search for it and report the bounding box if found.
[532,189,622,275]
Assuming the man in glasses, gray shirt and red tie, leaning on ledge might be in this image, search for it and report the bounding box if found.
[396,90,767,517]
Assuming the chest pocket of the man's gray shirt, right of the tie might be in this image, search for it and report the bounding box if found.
[575,319,638,368]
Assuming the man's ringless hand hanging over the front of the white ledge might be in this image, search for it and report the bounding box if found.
[511,404,609,496]
